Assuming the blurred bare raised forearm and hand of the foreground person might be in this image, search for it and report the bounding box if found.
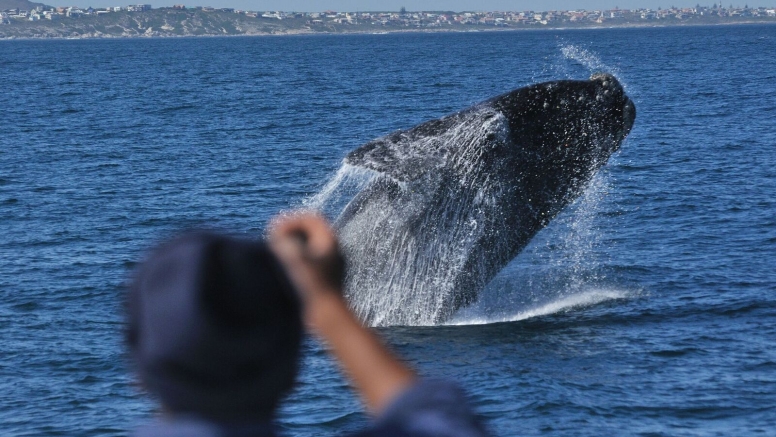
[269,213,416,415]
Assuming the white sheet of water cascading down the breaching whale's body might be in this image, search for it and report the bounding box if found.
[324,108,507,325]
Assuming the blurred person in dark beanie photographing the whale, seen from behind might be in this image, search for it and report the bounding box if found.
[127,213,487,437]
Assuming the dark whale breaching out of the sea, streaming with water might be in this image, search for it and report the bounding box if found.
[328,73,636,326]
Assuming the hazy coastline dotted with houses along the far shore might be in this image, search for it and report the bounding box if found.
[0,3,776,38]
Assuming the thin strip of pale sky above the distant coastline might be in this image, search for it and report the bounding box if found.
[127,0,756,12]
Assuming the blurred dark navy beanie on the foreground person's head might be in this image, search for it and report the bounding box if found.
[127,232,302,421]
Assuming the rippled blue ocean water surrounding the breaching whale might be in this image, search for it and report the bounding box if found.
[0,25,776,436]
